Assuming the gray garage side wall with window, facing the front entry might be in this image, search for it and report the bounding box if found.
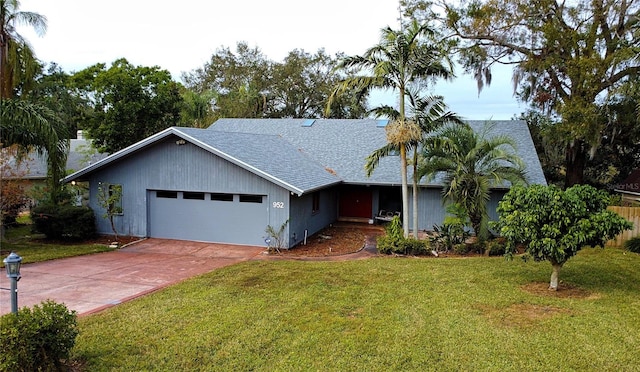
[289,187,338,247]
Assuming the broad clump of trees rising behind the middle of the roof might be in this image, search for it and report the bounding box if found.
[182,43,366,119]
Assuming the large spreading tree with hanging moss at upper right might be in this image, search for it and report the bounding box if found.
[420,0,640,186]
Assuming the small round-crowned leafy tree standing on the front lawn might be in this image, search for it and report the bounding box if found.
[495,185,633,291]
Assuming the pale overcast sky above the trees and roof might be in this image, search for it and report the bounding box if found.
[18,0,526,120]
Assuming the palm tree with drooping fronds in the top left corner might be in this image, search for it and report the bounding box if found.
[0,0,47,98]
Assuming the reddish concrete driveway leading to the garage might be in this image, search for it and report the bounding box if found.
[0,239,264,315]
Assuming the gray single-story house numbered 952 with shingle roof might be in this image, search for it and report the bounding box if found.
[65,119,546,247]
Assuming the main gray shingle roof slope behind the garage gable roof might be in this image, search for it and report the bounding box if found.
[208,119,546,186]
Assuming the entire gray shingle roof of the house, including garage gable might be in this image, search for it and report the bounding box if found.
[65,119,546,194]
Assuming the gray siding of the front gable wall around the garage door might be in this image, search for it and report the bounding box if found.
[89,137,289,245]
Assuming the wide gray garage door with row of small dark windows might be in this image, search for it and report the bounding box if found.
[148,190,268,246]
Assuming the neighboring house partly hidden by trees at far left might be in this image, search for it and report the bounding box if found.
[2,131,108,203]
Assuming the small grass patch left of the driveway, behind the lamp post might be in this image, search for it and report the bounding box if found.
[0,225,113,267]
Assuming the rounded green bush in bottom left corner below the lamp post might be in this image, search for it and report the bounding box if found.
[0,300,78,372]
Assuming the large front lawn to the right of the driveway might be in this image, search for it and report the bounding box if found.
[74,248,640,371]
